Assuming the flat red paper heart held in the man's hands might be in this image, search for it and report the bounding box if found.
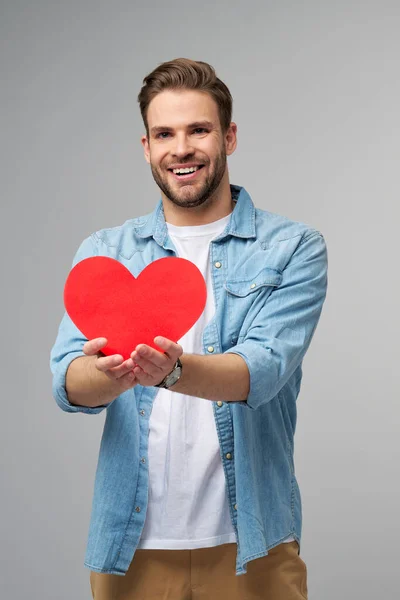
[64,256,207,360]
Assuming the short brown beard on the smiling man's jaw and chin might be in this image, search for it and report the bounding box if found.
[150,147,226,208]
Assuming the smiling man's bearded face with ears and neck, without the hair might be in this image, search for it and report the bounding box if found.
[142,89,231,220]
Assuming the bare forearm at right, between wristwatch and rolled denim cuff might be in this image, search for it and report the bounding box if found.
[170,353,250,402]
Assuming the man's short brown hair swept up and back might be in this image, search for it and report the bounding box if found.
[138,58,232,137]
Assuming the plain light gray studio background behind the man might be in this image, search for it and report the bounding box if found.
[0,0,400,600]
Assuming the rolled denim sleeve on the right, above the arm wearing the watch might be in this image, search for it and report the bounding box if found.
[225,230,327,410]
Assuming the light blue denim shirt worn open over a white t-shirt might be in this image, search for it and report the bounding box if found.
[50,185,327,575]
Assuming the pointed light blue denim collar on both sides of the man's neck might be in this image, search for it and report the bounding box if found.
[134,184,256,248]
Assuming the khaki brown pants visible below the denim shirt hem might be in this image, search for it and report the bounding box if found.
[90,542,307,600]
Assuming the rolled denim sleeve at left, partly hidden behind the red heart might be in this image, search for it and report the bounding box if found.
[50,235,111,414]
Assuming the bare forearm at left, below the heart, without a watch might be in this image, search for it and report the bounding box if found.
[65,356,121,407]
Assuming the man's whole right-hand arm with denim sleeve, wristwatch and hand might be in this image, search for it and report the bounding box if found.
[131,231,327,409]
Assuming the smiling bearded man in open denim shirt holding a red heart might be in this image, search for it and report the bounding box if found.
[51,59,327,600]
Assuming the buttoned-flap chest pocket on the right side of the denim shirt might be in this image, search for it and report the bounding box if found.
[224,267,282,343]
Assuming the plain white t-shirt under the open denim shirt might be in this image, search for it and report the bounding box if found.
[138,215,293,550]
